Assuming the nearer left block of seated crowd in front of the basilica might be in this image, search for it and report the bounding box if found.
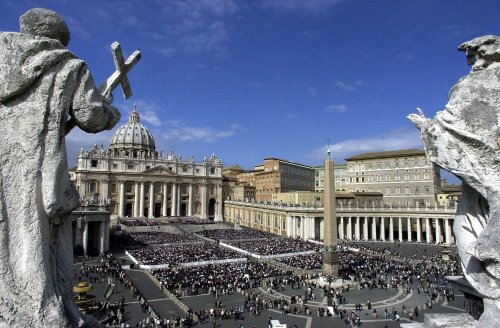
[128,243,243,266]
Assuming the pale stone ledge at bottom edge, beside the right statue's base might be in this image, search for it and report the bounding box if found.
[401,313,479,328]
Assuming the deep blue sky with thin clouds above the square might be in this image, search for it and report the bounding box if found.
[0,0,500,176]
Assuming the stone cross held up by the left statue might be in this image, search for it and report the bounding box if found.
[100,42,141,99]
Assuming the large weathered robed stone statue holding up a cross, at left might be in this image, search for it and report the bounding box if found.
[0,8,140,328]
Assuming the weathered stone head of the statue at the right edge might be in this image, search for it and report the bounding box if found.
[458,35,500,71]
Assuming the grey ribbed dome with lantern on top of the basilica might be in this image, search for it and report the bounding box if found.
[109,106,156,151]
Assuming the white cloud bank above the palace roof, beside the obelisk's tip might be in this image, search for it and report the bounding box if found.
[309,127,423,162]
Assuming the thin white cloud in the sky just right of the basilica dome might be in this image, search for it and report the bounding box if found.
[160,120,240,143]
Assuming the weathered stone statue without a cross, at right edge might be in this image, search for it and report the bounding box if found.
[408,35,500,327]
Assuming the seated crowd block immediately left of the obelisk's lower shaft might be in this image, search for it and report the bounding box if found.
[228,238,321,255]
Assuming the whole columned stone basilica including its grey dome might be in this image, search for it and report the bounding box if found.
[70,107,223,221]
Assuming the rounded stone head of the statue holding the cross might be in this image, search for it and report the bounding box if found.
[19,8,70,46]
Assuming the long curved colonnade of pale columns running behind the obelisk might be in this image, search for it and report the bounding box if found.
[224,201,455,245]
